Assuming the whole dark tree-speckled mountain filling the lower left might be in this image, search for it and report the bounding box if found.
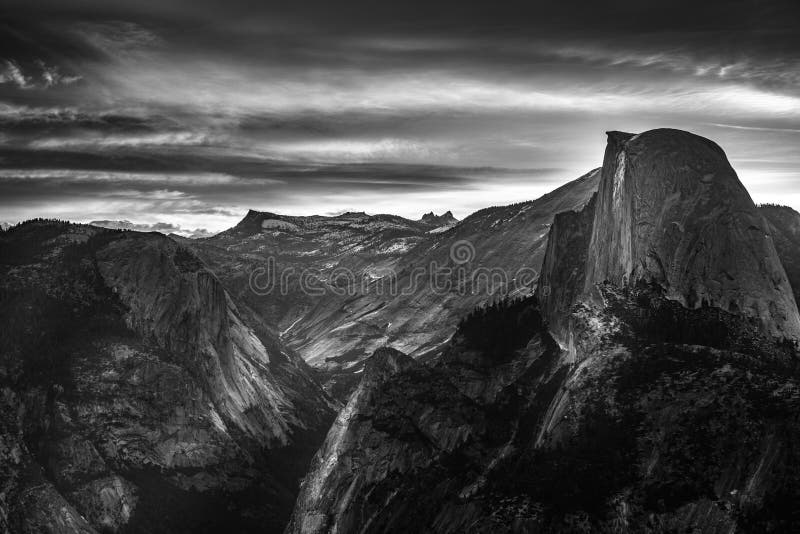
[0,220,336,532]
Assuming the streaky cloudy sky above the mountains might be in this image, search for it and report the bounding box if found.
[0,0,800,235]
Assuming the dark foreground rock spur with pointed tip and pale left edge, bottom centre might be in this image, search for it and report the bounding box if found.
[287,314,564,533]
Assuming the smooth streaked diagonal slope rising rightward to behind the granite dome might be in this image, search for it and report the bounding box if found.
[288,171,599,369]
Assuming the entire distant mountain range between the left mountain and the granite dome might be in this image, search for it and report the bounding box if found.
[188,170,599,397]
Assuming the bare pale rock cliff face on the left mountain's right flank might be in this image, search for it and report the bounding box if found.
[97,234,299,445]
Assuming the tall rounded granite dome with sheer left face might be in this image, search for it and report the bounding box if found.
[543,129,800,339]
